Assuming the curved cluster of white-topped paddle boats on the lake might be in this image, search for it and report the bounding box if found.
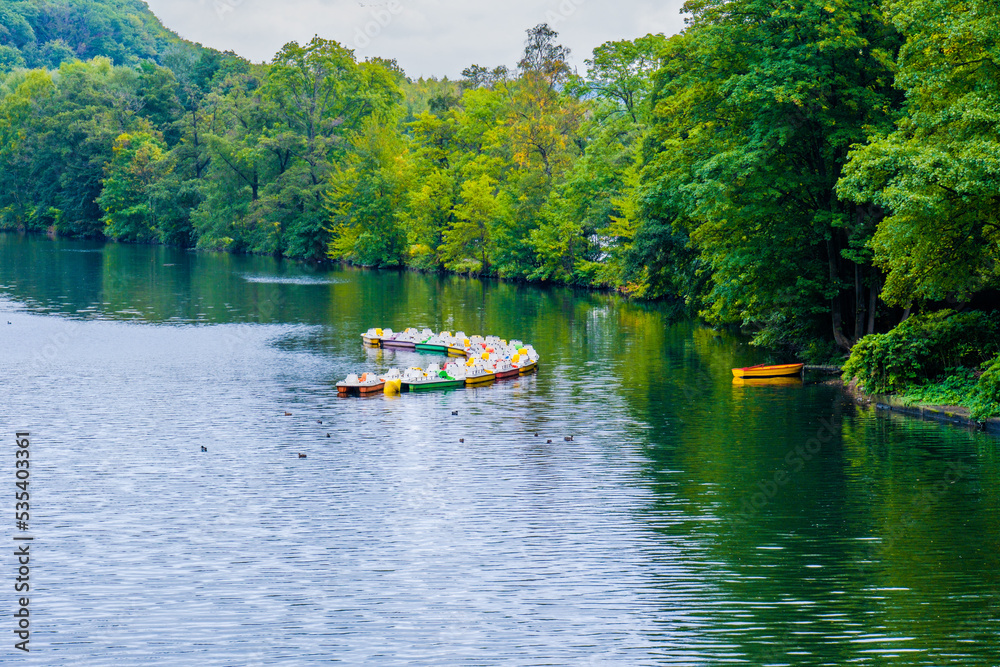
[337,328,538,396]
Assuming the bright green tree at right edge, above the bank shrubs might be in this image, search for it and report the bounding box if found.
[839,0,1000,306]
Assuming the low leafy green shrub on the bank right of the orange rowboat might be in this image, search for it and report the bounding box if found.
[844,310,1000,392]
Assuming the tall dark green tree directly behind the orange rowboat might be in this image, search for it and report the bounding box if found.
[640,0,898,349]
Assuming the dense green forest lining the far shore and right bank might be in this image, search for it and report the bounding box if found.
[0,0,1000,414]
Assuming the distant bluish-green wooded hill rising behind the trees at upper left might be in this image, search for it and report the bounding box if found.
[0,0,200,72]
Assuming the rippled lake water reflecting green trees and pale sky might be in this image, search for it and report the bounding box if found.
[0,234,1000,665]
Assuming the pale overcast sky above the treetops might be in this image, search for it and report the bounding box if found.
[146,0,684,78]
